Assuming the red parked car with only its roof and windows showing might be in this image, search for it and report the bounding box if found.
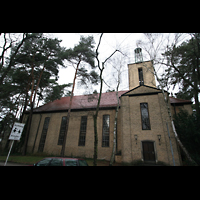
[32,157,88,166]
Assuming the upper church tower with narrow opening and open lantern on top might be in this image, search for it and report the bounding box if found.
[128,48,156,90]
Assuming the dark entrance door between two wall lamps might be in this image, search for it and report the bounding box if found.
[142,142,155,162]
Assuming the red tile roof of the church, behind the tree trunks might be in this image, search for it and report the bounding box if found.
[33,90,192,112]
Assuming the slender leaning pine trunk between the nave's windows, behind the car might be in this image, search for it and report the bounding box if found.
[60,58,81,157]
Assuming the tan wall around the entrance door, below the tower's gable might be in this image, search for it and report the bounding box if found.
[121,93,180,165]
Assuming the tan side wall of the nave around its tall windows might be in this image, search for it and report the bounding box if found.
[27,109,117,160]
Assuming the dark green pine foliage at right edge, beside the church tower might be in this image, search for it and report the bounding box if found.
[163,33,200,120]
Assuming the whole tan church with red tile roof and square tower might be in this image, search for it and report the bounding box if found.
[24,48,192,166]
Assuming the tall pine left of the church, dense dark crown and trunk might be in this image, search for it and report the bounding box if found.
[8,34,68,155]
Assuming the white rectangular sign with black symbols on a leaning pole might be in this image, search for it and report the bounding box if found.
[4,122,25,166]
